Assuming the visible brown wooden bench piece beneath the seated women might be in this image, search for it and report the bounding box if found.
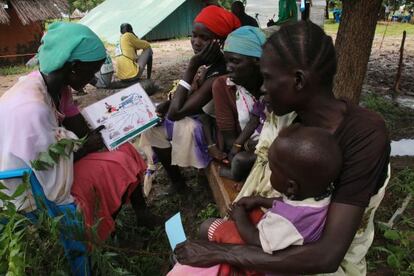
[206,162,239,216]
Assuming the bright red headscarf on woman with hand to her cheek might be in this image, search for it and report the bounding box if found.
[194,6,241,37]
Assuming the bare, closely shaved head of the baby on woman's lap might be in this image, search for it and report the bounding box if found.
[269,124,342,200]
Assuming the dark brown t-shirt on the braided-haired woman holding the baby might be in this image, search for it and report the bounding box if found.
[332,102,391,208]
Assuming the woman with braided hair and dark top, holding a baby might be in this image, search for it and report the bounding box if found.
[175,21,390,275]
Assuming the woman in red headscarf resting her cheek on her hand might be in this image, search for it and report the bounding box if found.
[140,6,240,190]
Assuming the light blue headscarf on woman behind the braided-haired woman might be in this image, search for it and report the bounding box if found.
[224,26,266,58]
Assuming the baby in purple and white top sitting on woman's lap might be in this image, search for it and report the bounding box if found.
[169,125,342,275]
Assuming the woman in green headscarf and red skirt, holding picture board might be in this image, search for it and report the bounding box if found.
[0,22,158,239]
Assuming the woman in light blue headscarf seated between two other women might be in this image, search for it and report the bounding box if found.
[210,26,266,181]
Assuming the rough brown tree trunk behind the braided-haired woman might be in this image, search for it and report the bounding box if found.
[334,0,382,103]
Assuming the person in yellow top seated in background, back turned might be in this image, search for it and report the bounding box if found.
[115,23,153,82]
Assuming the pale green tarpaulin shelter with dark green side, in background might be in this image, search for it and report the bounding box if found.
[80,0,204,44]
